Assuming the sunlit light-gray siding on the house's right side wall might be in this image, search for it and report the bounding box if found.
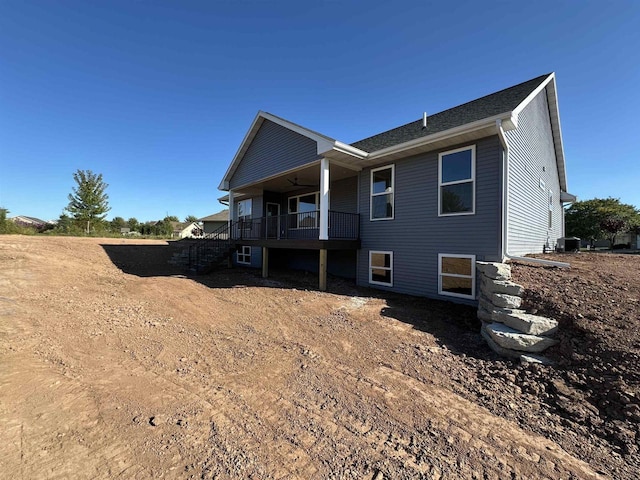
[506,91,564,255]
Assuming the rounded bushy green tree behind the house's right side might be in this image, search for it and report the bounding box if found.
[565,197,640,246]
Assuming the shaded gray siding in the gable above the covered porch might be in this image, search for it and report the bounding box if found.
[229,120,319,189]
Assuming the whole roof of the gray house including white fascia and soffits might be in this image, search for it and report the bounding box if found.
[218,73,567,192]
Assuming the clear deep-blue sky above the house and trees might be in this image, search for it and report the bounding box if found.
[0,0,640,221]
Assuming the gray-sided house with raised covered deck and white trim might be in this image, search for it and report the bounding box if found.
[214,73,575,303]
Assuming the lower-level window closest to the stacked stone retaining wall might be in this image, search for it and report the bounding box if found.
[438,253,476,299]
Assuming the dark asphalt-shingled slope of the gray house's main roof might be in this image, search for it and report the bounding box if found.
[351,74,551,152]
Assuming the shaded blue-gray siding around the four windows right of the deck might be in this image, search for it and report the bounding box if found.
[357,136,502,301]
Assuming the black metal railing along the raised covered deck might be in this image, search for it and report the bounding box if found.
[230,210,360,240]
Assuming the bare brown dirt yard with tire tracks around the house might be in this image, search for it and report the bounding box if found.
[0,236,640,480]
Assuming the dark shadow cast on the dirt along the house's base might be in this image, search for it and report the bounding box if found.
[101,244,490,359]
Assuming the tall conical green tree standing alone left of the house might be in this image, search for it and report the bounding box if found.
[66,170,111,232]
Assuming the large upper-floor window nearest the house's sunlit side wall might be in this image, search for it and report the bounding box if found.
[438,145,476,216]
